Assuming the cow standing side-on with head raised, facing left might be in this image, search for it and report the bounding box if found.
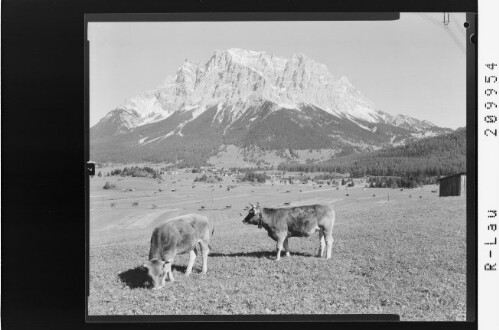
[243,204,335,260]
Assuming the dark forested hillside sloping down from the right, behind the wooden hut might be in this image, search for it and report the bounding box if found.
[279,129,466,178]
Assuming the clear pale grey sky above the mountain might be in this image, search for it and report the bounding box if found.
[88,13,466,128]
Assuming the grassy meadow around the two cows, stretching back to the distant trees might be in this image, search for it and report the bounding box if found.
[88,175,466,320]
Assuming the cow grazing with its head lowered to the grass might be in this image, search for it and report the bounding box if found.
[143,214,214,289]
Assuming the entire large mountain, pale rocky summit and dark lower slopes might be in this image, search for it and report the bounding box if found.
[90,49,452,161]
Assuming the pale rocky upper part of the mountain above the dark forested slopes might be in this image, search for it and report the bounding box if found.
[95,48,448,137]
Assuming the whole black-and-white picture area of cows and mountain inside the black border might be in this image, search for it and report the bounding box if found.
[87,12,467,321]
